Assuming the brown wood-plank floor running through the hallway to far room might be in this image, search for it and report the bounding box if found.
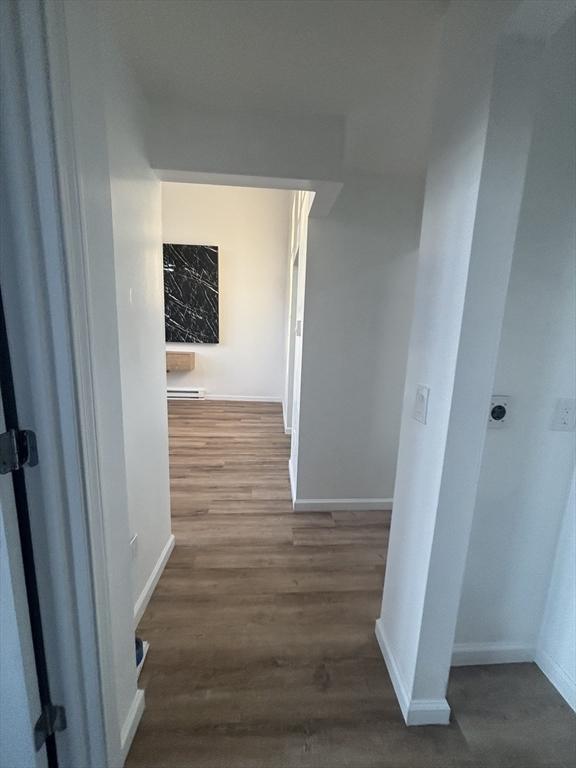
[127,401,575,768]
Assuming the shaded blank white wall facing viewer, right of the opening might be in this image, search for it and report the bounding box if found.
[293,176,423,508]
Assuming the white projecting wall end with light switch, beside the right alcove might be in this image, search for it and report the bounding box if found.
[377,2,538,724]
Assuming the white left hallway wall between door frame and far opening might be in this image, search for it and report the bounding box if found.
[58,2,170,766]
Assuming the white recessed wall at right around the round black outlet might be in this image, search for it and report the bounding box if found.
[456,16,576,708]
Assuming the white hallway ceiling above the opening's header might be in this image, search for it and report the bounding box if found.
[99,0,446,176]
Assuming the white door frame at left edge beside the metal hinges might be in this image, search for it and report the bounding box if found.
[0,0,111,768]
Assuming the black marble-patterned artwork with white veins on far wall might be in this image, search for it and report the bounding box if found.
[164,243,219,344]
